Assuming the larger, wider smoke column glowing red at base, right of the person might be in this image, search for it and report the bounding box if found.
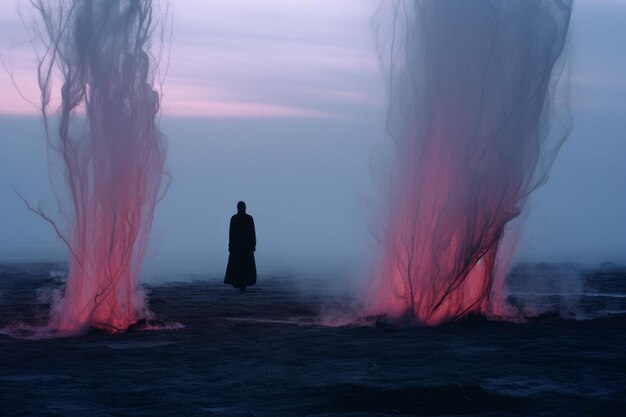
[366,0,572,325]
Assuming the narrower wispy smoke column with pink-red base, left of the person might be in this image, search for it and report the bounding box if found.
[33,0,165,332]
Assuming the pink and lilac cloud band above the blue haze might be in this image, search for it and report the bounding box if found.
[0,0,384,118]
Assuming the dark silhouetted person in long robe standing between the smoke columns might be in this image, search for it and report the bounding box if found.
[224,201,256,292]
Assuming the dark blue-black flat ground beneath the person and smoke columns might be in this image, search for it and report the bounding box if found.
[0,264,626,416]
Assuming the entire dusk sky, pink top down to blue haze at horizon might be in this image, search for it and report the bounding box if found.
[0,0,626,279]
